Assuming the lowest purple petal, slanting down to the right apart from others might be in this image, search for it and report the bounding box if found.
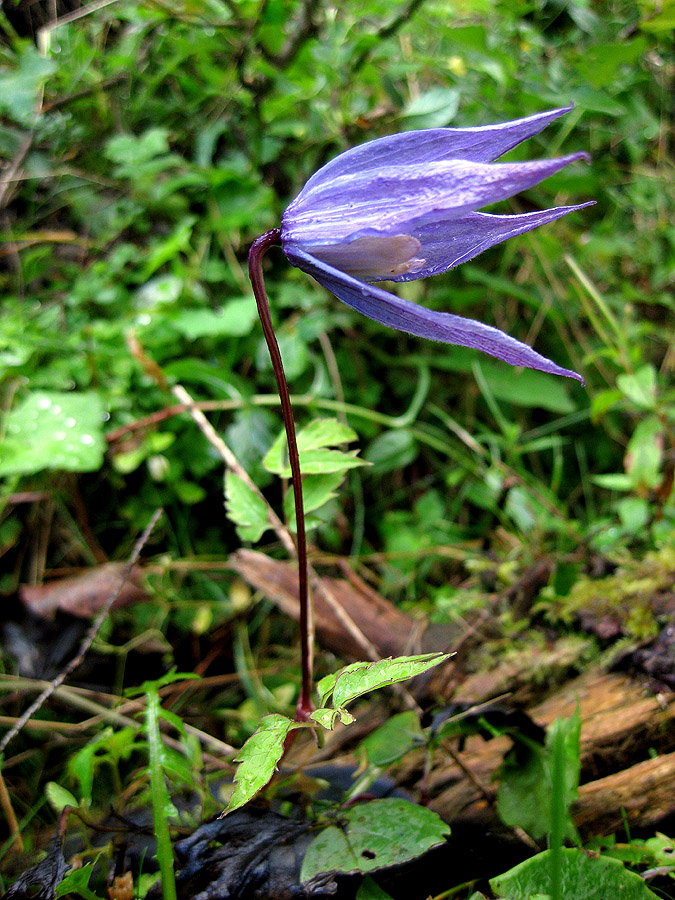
[287,249,584,384]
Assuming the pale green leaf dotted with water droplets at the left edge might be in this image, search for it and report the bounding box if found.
[0,391,106,478]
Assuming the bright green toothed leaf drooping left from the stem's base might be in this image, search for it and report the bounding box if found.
[227,713,295,812]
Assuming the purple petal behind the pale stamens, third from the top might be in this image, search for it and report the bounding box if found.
[380,200,595,281]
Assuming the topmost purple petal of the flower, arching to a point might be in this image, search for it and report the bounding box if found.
[291,106,572,205]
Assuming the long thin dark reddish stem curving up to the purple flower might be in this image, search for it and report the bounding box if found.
[248,228,314,722]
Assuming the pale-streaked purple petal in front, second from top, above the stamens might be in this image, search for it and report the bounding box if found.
[281,153,586,244]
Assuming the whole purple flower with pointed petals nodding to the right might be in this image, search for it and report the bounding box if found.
[281,107,591,384]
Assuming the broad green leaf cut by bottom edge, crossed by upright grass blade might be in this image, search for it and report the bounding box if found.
[490,849,657,900]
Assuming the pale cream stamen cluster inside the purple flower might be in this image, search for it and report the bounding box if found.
[307,234,426,281]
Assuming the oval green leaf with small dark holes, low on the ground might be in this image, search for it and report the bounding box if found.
[300,799,450,883]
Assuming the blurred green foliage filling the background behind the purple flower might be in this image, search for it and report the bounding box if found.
[0,0,675,884]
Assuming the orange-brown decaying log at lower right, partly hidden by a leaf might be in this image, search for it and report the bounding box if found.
[429,670,675,836]
